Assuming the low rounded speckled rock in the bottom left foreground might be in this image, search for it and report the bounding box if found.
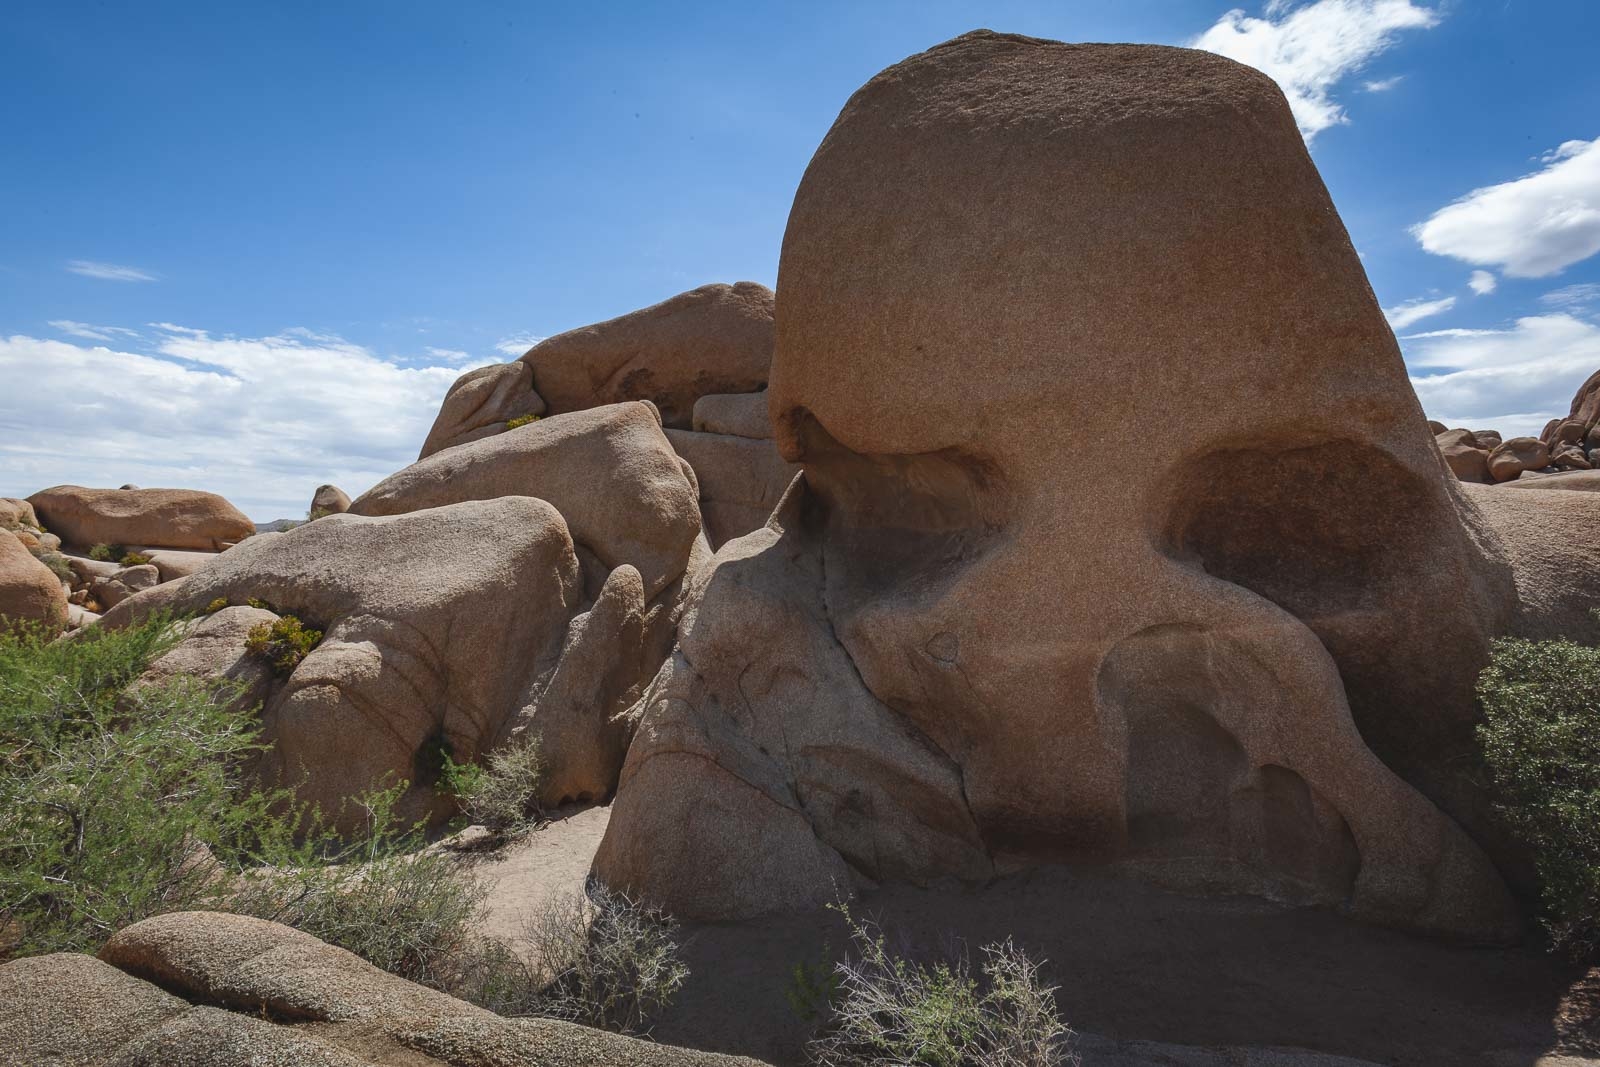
[0,912,760,1067]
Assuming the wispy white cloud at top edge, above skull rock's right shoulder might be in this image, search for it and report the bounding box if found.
[1190,0,1438,141]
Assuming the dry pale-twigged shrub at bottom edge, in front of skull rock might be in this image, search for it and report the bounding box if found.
[810,905,1078,1067]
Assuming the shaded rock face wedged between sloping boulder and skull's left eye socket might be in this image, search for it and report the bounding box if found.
[667,429,800,549]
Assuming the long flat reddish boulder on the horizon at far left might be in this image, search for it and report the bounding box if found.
[27,485,256,550]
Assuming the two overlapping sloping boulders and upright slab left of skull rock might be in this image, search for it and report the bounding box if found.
[106,403,706,817]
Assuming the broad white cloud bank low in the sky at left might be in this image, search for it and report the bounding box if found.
[0,323,459,522]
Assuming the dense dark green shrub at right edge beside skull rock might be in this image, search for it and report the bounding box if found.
[1478,640,1600,958]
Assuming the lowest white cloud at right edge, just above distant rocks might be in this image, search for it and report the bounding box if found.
[1403,314,1600,437]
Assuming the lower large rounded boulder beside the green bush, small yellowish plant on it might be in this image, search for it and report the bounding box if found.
[102,496,595,822]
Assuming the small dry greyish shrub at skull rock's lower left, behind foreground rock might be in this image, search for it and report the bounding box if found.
[493,881,690,1033]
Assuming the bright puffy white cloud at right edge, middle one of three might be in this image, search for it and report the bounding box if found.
[1411,138,1600,278]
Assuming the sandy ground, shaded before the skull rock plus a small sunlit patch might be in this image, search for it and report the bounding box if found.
[457,808,1600,1067]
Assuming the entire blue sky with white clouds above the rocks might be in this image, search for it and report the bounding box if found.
[0,0,1600,520]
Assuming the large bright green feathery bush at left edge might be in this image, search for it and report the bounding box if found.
[0,616,496,993]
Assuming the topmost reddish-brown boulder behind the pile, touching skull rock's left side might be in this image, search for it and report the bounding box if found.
[522,282,773,429]
